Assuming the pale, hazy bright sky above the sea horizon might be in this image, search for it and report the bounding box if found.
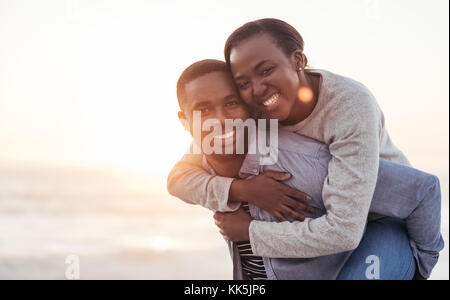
[0,0,449,177]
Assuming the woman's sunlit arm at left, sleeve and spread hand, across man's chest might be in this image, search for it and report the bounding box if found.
[167,148,311,216]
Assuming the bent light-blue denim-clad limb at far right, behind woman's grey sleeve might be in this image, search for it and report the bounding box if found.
[370,159,444,278]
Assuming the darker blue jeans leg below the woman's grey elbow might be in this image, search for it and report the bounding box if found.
[337,217,416,280]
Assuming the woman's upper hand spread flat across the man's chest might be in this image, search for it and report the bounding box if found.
[230,171,314,221]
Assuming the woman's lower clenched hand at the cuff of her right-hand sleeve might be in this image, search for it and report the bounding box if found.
[214,207,253,242]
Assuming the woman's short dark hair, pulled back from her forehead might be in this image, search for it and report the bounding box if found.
[225,19,308,66]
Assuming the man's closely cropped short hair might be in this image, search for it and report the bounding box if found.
[177,59,230,110]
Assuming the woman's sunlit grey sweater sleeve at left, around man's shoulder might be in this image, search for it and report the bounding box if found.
[167,149,240,212]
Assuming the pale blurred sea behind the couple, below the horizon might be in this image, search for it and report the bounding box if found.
[0,163,449,280]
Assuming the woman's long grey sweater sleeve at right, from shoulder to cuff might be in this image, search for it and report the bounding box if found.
[249,89,382,258]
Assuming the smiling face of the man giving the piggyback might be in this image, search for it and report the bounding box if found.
[178,64,250,177]
